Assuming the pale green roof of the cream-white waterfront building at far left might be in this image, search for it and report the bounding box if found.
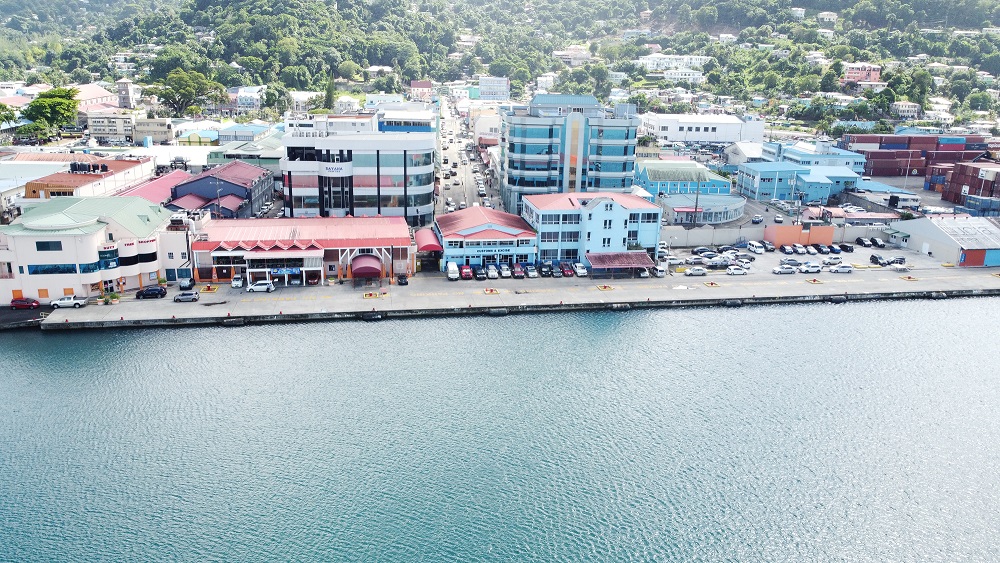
[0,197,173,238]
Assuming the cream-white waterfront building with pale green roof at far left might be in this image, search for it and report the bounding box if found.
[0,197,191,303]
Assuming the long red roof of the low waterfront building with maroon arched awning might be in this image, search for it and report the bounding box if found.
[192,217,412,250]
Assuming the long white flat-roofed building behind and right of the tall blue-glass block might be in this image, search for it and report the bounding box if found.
[640,113,764,144]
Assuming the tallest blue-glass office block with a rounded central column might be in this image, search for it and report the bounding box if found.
[500,94,639,213]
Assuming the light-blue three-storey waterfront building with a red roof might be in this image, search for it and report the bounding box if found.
[521,192,662,266]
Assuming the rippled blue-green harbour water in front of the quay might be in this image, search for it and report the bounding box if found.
[0,299,1000,562]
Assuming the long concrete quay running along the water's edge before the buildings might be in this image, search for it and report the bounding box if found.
[21,247,1000,330]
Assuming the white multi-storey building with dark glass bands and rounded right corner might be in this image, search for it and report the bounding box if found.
[281,115,437,226]
